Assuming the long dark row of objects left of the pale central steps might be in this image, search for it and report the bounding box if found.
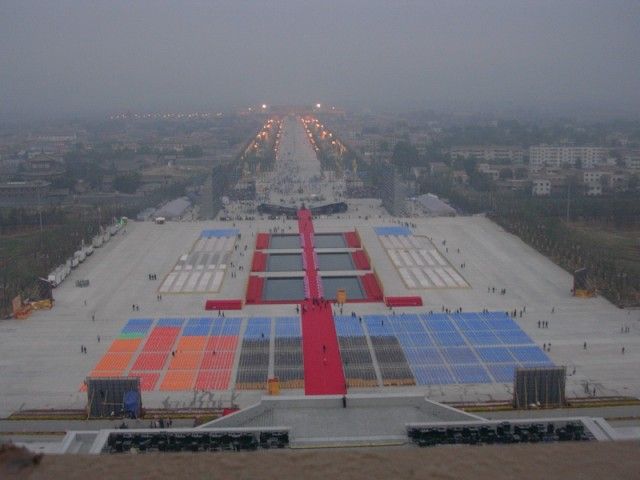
[105,431,289,453]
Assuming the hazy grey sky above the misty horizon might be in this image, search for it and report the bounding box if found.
[0,0,640,117]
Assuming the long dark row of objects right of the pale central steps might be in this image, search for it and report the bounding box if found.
[407,422,592,447]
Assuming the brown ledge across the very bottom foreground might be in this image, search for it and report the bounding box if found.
[0,442,640,480]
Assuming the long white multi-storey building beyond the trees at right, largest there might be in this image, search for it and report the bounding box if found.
[529,145,607,171]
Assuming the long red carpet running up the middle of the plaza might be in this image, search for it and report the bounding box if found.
[298,210,347,395]
